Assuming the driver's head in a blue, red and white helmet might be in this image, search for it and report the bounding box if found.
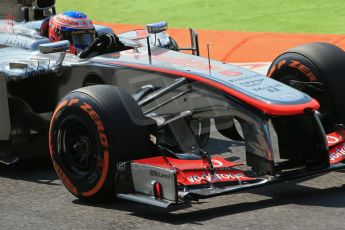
[49,11,96,54]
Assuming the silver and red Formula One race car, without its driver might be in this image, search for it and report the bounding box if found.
[0,0,345,209]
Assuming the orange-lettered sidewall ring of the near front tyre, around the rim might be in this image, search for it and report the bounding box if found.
[50,93,117,197]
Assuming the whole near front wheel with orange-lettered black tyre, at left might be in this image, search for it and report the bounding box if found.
[49,85,151,201]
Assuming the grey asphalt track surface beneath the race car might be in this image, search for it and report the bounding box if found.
[0,124,345,230]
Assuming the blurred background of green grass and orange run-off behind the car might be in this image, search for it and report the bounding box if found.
[57,0,345,63]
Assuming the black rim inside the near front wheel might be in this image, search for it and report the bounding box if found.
[58,117,96,177]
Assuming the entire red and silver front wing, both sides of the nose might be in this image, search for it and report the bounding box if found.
[117,129,345,211]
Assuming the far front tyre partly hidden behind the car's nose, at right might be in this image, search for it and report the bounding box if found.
[267,42,345,132]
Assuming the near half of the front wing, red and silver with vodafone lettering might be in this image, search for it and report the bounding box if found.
[117,157,267,209]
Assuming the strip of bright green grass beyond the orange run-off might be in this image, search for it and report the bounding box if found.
[57,0,345,34]
